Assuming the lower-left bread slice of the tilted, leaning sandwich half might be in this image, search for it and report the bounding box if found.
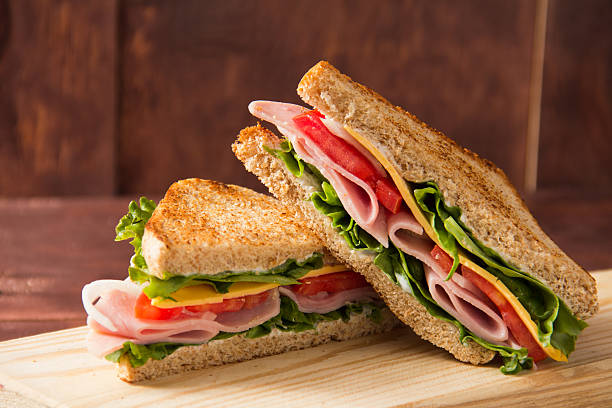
[232,125,495,364]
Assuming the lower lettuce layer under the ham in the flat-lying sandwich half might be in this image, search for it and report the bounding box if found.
[105,296,382,367]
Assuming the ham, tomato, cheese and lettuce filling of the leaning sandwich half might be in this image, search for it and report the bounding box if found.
[249,101,586,373]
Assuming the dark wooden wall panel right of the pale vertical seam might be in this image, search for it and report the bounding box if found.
[538,0,612,190]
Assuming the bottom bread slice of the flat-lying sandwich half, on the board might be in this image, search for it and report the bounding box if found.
[118,309,399,382]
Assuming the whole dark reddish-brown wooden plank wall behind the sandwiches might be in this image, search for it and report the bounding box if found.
[0,0,612,197]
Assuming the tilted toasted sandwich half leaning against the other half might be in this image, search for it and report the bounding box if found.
[232,61,598,374]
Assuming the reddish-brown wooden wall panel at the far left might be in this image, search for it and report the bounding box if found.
[0,0,117,196]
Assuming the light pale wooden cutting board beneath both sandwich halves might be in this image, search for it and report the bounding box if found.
[0,271,612,408]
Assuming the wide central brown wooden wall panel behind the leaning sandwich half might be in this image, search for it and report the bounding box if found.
[118,0,534,193]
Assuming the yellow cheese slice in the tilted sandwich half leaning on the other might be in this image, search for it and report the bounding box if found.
[344,126,567,361]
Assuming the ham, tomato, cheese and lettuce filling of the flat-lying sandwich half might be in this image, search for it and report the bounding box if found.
[83,198,384,367]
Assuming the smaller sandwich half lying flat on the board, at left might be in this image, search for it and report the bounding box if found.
[82,179,399,382]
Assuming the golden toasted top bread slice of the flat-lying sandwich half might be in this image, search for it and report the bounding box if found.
[142,178,324,277]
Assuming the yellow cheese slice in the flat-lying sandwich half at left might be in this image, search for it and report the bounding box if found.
[151,265,348,309]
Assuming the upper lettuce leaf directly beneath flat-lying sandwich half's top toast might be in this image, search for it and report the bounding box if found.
[115,197,323,299]
